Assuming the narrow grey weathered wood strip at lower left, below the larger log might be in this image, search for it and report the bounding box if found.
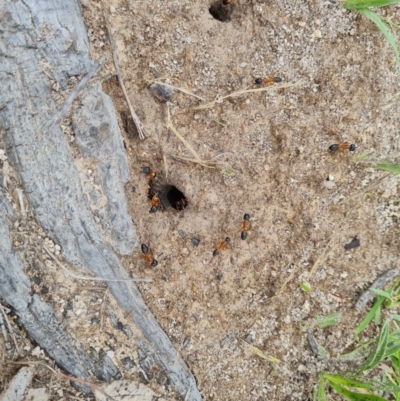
[0,188,116,390]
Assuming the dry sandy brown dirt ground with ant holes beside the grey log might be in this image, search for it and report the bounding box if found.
[2,0,400,401]
